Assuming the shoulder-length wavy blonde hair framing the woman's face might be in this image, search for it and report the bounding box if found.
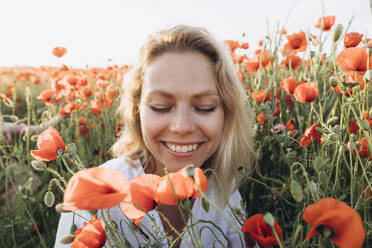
[112,25,254,190]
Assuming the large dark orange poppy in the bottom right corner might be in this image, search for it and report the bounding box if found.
[302,198,366,248]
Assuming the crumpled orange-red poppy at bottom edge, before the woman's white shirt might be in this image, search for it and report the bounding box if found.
[71,216,106,248]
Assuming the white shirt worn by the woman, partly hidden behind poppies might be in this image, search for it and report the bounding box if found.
[54,157,245,248]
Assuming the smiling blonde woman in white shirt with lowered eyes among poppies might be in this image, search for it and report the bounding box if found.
[56,26,254,247]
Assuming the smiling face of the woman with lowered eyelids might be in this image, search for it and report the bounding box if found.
[140,51,224,174]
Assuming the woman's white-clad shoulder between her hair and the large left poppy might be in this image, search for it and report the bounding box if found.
[99,156,144,180]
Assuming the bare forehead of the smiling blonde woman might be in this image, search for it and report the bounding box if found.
[142,51,217,94]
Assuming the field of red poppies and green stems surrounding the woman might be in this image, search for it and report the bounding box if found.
[0,16,372,248]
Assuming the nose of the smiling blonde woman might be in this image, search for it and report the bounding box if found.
[169,107,196,134]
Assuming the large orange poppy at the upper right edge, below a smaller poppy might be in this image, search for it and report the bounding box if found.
[336,47,372,72]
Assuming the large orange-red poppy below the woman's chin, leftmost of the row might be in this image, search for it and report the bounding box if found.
[63,167,128,211]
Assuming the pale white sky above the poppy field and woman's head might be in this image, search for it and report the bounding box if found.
[0,0,372,67]
